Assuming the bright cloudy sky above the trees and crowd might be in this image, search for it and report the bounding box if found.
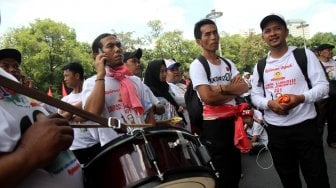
[0,0,336,43]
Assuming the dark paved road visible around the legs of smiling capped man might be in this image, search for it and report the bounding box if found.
[240,131,336,188]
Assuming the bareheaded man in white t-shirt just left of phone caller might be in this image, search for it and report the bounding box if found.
[58,62,100,164]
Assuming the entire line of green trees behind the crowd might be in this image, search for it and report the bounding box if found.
[0,19,336,95]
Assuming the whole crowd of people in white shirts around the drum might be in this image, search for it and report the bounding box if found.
[0,14,336,188]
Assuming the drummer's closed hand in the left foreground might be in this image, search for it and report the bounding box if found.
[17,118,74,168]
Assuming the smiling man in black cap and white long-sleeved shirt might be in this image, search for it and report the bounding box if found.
[251,14,330,188]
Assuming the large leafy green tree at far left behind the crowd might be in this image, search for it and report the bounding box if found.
[1,19,92,96]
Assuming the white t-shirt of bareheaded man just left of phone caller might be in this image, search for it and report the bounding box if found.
[62,92,99,150]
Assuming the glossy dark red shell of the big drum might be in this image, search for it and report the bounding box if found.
[84,127,215,188]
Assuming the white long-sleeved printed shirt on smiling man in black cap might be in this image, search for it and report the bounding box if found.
[251,47,329,126]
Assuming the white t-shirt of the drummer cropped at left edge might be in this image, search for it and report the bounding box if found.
[0,68,83,188]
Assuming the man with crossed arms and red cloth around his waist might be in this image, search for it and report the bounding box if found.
[189,19,250,187]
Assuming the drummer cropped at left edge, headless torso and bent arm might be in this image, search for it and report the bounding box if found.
[0,68,83,188]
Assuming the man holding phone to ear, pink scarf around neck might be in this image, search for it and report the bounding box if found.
[82,33,152,145]
